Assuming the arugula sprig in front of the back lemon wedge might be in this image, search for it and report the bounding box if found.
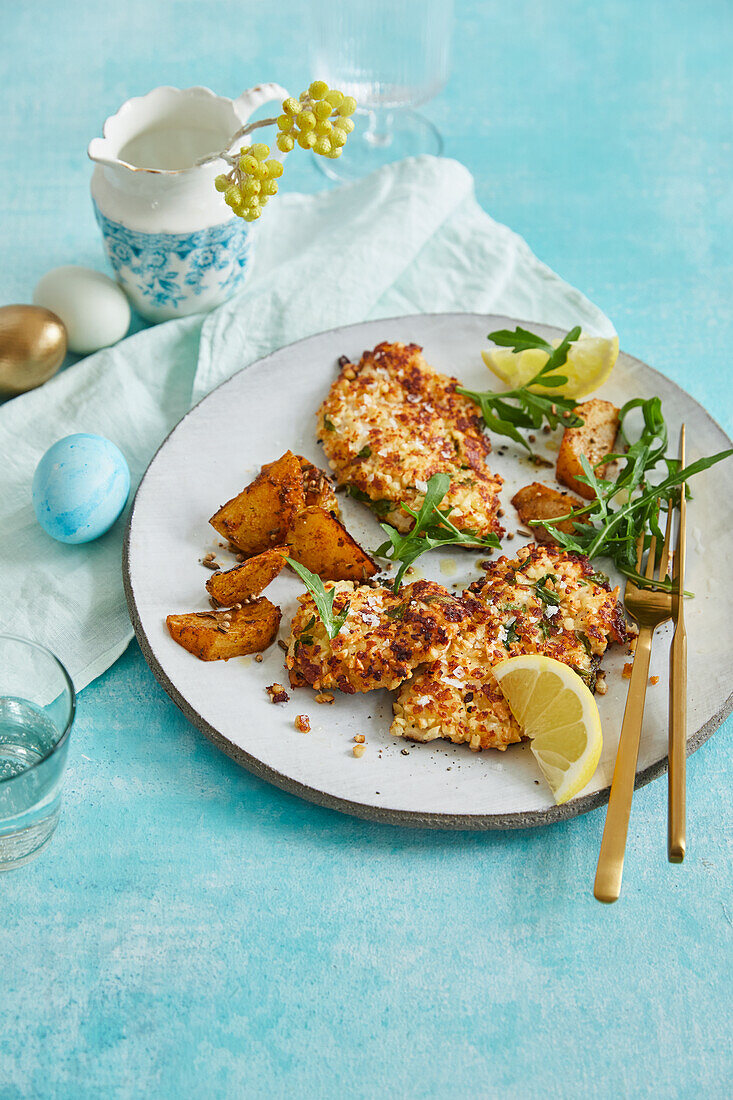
[456,326,583,454]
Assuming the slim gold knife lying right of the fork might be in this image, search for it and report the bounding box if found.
[667,425,687,864]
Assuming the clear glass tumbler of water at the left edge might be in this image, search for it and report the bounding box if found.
[0,634,76,871]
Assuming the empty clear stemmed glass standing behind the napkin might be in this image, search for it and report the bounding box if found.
[310,0,453,179]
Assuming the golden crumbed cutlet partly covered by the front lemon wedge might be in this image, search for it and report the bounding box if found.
[391,546,626,751]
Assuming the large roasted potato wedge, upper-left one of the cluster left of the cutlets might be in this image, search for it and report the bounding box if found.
[209,451,305,557]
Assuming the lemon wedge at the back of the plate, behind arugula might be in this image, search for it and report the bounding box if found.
[481,333,619,397]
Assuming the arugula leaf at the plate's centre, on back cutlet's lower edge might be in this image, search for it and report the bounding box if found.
[375,473,501,592]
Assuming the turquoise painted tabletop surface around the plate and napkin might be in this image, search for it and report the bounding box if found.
[0,0,733,1100]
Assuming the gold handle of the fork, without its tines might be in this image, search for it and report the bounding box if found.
[593,627,652,902]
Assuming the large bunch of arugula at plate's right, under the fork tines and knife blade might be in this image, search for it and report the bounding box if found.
[529,397,733,591]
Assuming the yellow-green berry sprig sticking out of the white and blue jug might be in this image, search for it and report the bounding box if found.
[206,80,357,221]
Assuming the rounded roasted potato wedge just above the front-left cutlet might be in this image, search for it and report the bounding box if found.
[287,508,379,581]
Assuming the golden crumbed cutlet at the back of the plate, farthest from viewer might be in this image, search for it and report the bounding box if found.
[318,343,503,536]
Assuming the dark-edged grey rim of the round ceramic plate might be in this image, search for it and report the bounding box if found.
[122,312,733,831]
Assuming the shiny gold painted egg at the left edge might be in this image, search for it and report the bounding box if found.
[0,306,66,396]
